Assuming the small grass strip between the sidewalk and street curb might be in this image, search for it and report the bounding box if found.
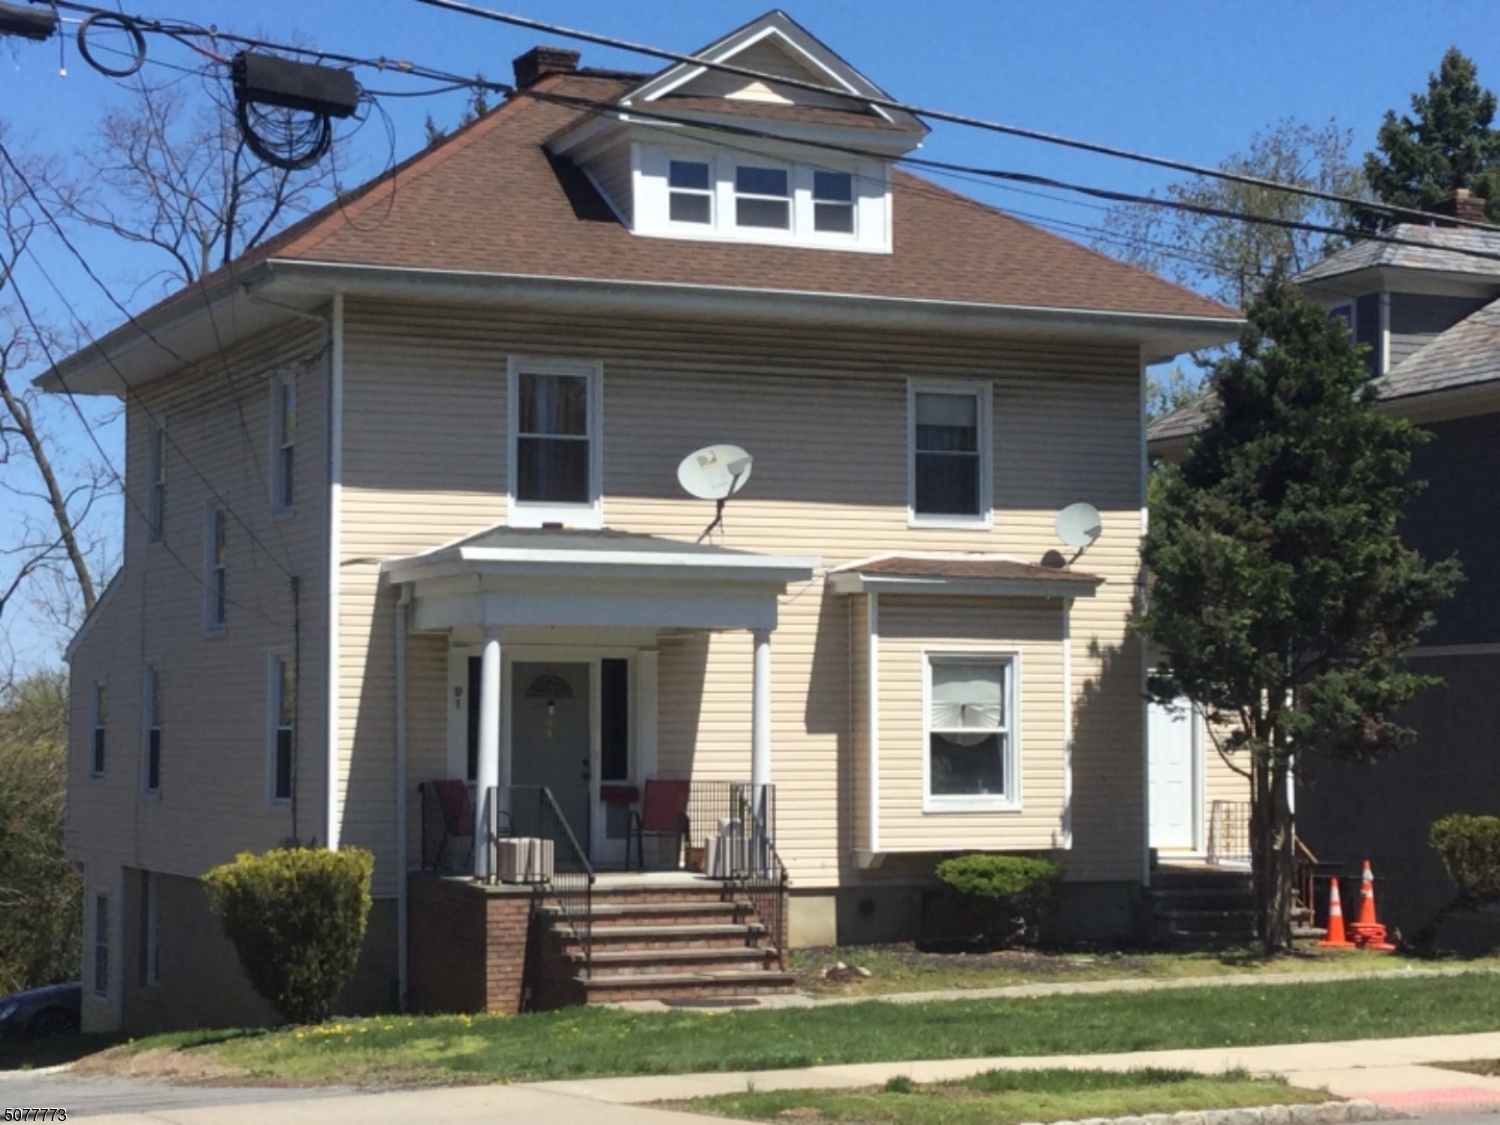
[669,1070,1329,1125]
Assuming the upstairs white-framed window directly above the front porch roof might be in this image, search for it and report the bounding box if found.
[510,357,603,527]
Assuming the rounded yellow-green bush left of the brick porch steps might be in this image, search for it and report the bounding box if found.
[203,848,375,1023]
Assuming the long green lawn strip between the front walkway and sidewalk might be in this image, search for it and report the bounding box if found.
[111,974,1500,1085]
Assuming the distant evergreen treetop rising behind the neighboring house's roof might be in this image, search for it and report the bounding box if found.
[1355,47,1500,230]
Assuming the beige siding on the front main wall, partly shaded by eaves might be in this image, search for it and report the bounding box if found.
[339,302,1143,893]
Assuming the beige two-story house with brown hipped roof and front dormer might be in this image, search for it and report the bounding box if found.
[44,12,1239,1031]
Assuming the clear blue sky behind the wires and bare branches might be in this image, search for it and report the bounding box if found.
[0,0,1500,662]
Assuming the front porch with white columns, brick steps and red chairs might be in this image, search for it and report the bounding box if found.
[383,527,818,1011]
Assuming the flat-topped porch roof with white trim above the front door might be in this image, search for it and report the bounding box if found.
[381,525,821,630]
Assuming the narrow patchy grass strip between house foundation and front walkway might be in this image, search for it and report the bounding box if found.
[791,944,1500,996]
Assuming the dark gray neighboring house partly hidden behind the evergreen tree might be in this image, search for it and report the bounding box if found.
[1149,198,1500,935]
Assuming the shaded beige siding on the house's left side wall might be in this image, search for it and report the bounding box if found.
[68,321,327,888]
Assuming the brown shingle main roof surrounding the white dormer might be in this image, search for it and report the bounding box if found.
[206,74,1238,320]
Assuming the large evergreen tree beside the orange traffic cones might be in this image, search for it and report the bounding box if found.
[1139,278,1460,950]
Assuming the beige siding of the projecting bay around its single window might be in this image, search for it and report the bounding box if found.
[878,596,1067,852]
